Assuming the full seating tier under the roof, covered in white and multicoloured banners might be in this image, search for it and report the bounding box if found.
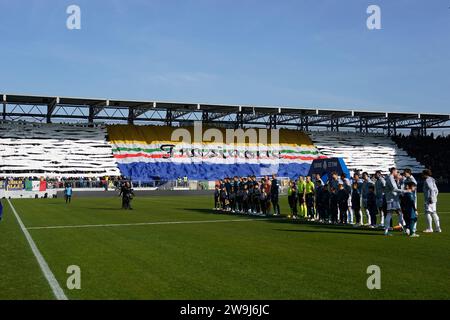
[0,122,432,182]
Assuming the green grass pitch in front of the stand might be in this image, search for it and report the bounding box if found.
[0,194,450,299]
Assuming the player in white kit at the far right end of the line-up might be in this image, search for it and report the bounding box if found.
[423,169,442,233]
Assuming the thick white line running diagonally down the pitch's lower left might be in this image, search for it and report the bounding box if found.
[7,199,68,300]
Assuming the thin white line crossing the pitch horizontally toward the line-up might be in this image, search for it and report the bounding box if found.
[27,218,273,230]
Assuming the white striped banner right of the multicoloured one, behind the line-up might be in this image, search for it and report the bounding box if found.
[309,132,425,174]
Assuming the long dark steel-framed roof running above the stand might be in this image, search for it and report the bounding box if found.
[0,94,450,135]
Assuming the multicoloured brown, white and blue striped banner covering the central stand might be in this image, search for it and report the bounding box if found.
[108,125,321,181]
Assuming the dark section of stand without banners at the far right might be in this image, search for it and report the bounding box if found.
[393,134,450,182]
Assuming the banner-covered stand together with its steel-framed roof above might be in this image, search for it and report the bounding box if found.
[0,94,449,182]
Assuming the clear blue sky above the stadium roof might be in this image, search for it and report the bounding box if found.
[0,0,450,113]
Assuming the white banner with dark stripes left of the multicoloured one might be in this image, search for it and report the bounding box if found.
[0,122,120,178]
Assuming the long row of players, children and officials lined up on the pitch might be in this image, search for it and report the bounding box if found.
[214,168,442,237]
